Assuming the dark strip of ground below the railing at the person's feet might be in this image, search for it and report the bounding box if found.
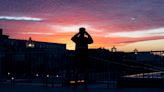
[0,85,164,92]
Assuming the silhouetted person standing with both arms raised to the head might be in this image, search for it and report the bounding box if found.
[71,27,93,88]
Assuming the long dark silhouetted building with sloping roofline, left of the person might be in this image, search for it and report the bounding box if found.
[0,29,66,75]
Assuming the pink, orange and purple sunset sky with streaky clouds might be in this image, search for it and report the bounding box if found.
[0,0,164,51]
